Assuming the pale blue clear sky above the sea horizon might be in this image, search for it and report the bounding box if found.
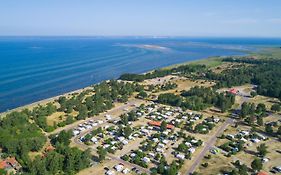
[0,0,281,38]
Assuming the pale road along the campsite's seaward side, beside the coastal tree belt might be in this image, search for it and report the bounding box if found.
[46,99,143,136]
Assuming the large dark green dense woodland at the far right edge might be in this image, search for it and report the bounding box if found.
[206,58,281,99]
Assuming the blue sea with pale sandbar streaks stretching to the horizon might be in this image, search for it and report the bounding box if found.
[0,37,281,112]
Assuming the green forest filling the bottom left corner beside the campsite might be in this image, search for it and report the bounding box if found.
[0,110,91,175]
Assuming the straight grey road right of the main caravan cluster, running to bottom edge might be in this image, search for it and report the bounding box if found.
[186,118,234,175]
